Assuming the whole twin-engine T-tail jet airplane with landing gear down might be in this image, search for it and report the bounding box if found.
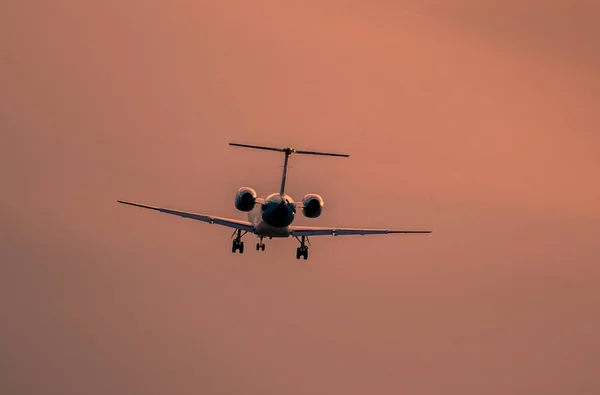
[117,143,432,260]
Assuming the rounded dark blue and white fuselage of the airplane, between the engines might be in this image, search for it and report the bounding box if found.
[248,193,296,237]
